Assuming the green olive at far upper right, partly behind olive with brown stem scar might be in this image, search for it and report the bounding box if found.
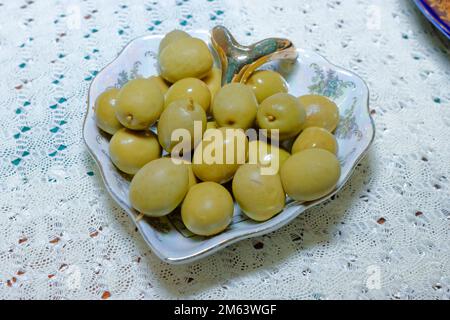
[298,95,339,132]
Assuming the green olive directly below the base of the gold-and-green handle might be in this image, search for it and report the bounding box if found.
[212,83,258,130]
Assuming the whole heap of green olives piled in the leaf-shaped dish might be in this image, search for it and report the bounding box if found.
[95,30,341,236]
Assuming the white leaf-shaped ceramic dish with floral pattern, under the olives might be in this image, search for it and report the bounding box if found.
[83,31,375,264]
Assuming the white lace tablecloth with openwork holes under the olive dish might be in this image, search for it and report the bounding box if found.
[0,0,450,299]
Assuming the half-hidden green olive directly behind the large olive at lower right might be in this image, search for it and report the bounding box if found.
[292,127,337,154]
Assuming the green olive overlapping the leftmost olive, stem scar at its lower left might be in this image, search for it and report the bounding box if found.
[116,78,164,130]
